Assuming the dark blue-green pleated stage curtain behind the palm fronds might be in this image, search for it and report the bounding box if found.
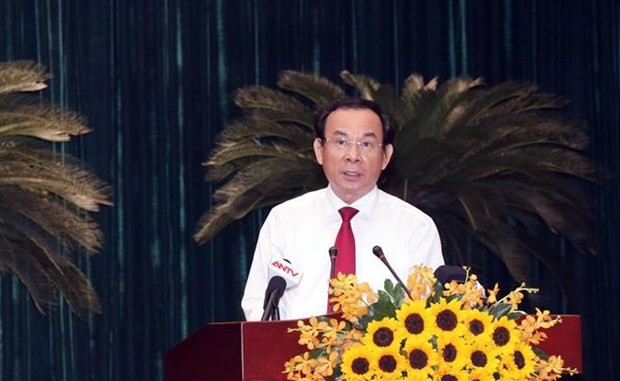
[0,0,620,381]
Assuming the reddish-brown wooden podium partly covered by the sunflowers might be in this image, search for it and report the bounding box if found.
[164,315,583,381]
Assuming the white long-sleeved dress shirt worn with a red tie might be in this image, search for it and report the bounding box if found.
[241,187,444,320]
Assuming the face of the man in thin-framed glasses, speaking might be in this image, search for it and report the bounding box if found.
[314,109,394,204]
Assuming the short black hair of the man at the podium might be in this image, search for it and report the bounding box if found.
[314,98,396,147]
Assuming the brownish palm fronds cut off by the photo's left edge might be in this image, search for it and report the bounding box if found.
[0,61,111,317]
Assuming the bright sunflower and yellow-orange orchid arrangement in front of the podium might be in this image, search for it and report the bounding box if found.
[284,266,576,381]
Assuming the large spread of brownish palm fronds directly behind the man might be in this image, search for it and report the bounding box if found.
[195,71,601,302]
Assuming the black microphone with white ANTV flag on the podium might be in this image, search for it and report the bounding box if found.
[261,258,303,320]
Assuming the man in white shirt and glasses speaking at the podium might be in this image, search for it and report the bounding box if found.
[241,98,443,320]
